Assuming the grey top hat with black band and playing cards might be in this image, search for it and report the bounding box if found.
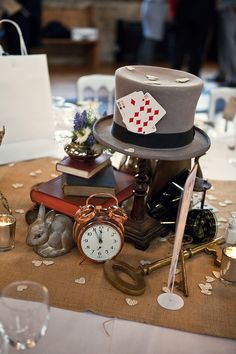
[94,65,210,161]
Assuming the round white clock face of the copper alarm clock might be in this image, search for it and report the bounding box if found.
[80,222,123,262]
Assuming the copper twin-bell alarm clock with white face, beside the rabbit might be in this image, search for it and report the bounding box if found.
[73,193,128,262]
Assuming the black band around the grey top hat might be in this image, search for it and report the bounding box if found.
[111,122,194,149]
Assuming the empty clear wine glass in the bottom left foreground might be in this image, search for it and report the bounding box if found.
[0,280,49,350]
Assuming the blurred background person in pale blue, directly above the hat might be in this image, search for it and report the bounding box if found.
[138,0,167,65]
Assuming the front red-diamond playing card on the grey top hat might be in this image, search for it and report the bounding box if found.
[123,93,166,134]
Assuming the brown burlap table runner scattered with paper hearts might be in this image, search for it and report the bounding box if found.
[0,158,236,338]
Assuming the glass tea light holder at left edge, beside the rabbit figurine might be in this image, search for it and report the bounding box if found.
[0,214,16,251]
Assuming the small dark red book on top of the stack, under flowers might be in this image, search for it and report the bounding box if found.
[56,154,111,178]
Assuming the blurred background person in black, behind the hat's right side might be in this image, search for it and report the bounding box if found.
[170,0,216,76]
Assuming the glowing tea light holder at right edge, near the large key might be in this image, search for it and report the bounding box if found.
[220,246,236,283]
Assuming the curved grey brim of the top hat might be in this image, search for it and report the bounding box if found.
[93,115,211,161]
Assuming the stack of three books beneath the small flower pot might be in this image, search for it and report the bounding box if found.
[30,154,134,217]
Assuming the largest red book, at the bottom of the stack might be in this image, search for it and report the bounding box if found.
[30,171,134,217]
